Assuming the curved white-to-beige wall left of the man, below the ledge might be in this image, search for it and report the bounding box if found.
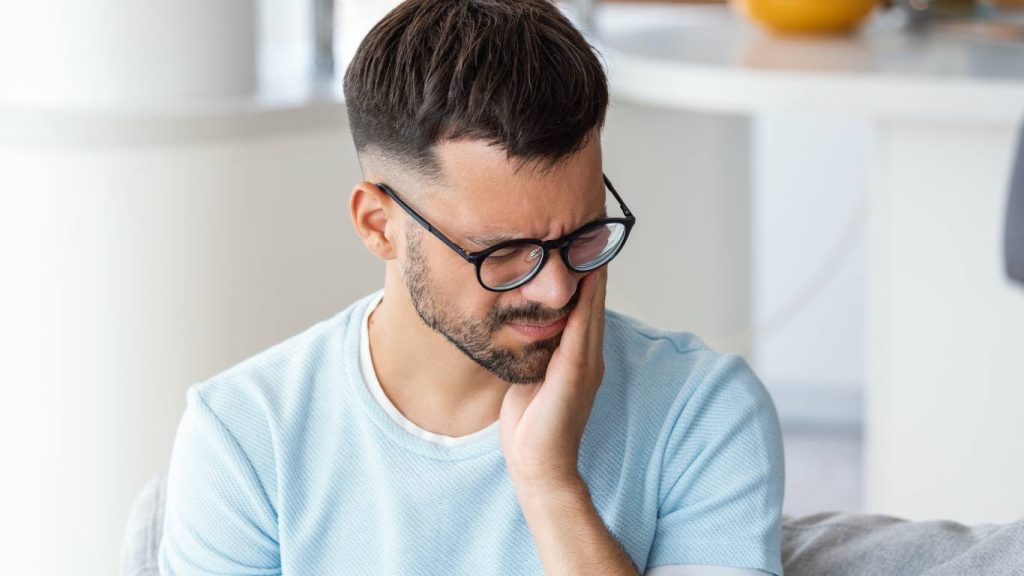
[0,124,382,576]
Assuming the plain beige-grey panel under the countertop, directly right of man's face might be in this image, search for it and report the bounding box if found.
[602,101,751,355]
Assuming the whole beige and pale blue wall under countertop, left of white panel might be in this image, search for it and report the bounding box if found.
[603,101,872,434]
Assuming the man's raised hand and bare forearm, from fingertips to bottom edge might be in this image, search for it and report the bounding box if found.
[500,268,638,576]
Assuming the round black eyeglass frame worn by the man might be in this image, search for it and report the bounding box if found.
[377,173,637,292]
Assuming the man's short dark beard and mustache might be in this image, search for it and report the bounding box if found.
[402,229,580,384]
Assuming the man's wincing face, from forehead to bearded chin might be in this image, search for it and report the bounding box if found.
[393,132,605,383]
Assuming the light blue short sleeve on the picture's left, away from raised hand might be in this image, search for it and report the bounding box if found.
[159,386,281,576]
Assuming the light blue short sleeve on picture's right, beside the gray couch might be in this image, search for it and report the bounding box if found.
[647,356,785,576]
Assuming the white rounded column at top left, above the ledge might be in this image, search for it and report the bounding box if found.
[0,0,257,108]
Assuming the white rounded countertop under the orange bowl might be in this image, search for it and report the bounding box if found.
[594,5,1024,123]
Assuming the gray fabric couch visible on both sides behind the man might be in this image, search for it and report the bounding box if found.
[121,475,1024,576]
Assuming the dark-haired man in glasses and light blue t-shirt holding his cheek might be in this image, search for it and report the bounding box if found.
[160,0,783,576]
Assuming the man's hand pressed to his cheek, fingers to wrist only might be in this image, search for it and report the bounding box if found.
[500,266,608,498]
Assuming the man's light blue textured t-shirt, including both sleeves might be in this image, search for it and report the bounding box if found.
[160,293,784,576]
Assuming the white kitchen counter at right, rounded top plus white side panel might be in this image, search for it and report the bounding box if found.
[594,5,1024,523]
